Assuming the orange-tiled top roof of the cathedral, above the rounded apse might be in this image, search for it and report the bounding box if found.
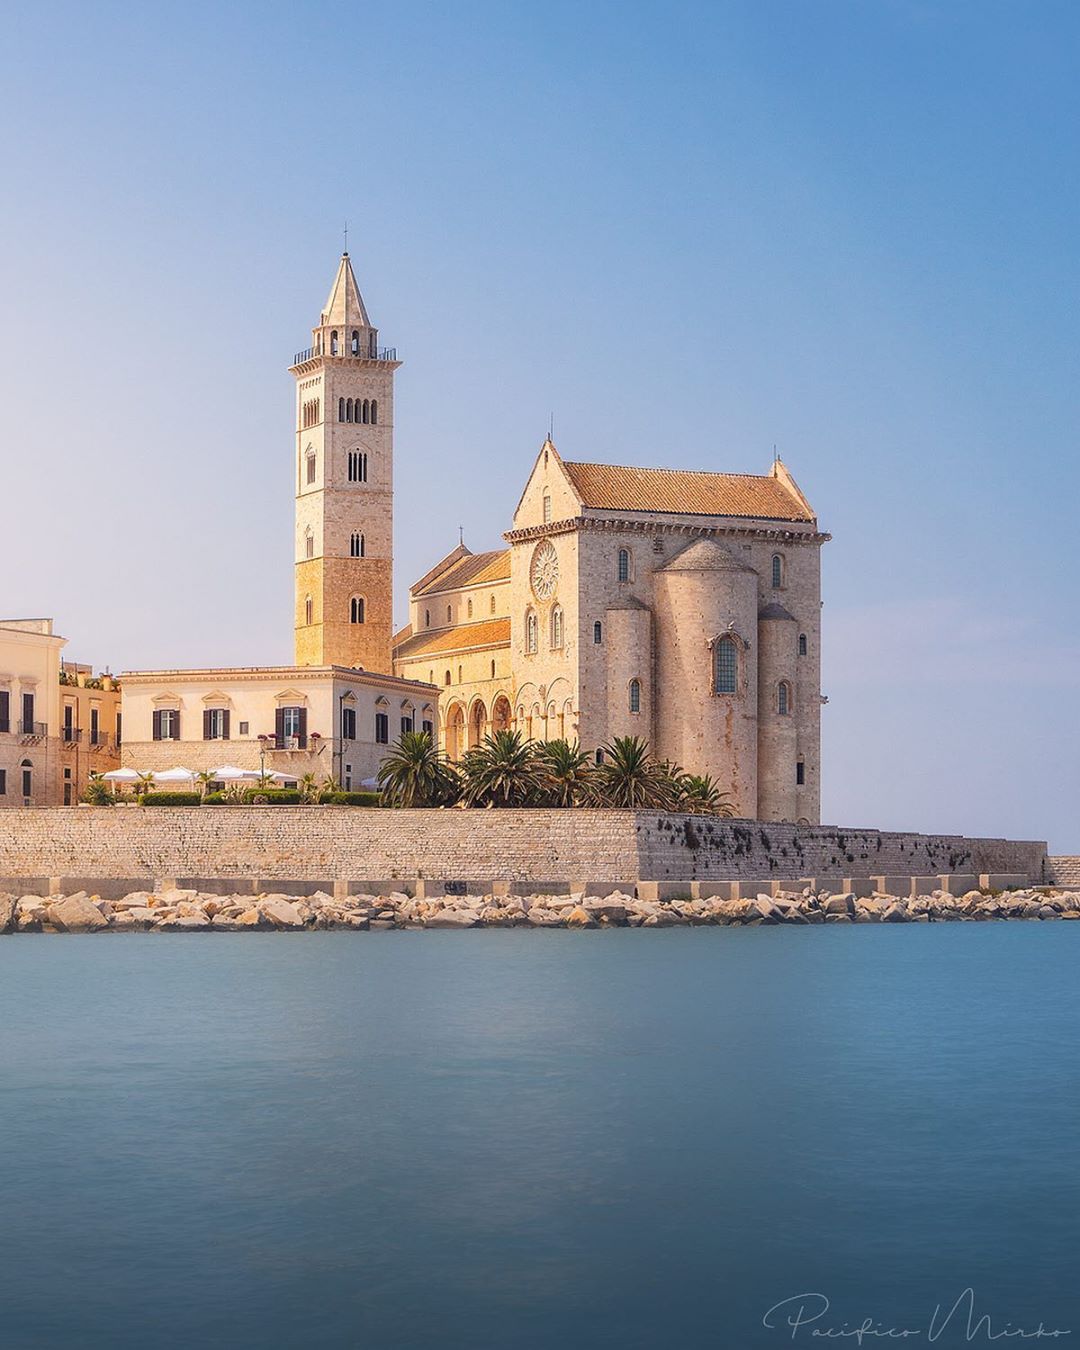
[562,459,814,521]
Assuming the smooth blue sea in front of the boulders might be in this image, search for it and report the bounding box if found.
[0,923,1080,1350]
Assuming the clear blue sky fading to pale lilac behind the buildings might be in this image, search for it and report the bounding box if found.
[0,0,1080,849]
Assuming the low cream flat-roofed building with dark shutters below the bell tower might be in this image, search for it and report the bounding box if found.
[122,666,439,788]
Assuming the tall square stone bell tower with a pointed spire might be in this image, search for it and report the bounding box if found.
[289,252,401,674]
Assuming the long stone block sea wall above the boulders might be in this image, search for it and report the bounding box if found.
[0,806,1046,890]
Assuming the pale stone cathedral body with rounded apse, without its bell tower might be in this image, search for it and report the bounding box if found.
[394,441,829,824]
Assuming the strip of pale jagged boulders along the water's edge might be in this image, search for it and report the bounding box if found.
[0,887,1080,933]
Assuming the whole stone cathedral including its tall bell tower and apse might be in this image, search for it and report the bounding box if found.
[292,254,829,825]
